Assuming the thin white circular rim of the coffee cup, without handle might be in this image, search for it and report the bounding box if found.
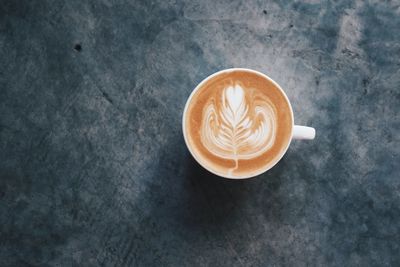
[182,68,294,180]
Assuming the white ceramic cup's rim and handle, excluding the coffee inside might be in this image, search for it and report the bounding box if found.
[182,68,315,179]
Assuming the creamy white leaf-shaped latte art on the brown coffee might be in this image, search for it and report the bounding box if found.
[201,85,276,175]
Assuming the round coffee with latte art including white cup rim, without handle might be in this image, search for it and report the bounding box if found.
[183,70,293,178]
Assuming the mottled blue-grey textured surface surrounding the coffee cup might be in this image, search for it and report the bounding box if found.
[0,0,400,266]
